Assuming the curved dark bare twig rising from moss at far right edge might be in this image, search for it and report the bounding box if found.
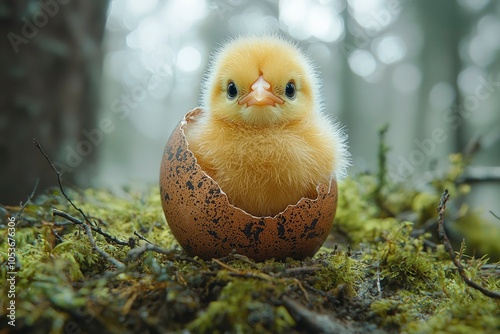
[438,189,500,299]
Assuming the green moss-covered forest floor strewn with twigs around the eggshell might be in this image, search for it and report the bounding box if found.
[0,155,500,333]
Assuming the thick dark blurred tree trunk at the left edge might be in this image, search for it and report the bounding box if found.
[0,0,108,204]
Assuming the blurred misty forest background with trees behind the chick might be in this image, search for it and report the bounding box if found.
[0,0,500,224]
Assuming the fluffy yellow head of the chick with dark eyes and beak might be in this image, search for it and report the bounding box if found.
[202,36,321,126]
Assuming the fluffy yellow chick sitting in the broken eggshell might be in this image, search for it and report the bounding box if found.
[185,36,349,216]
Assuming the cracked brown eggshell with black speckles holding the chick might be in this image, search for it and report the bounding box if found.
[160,108,337,261]
